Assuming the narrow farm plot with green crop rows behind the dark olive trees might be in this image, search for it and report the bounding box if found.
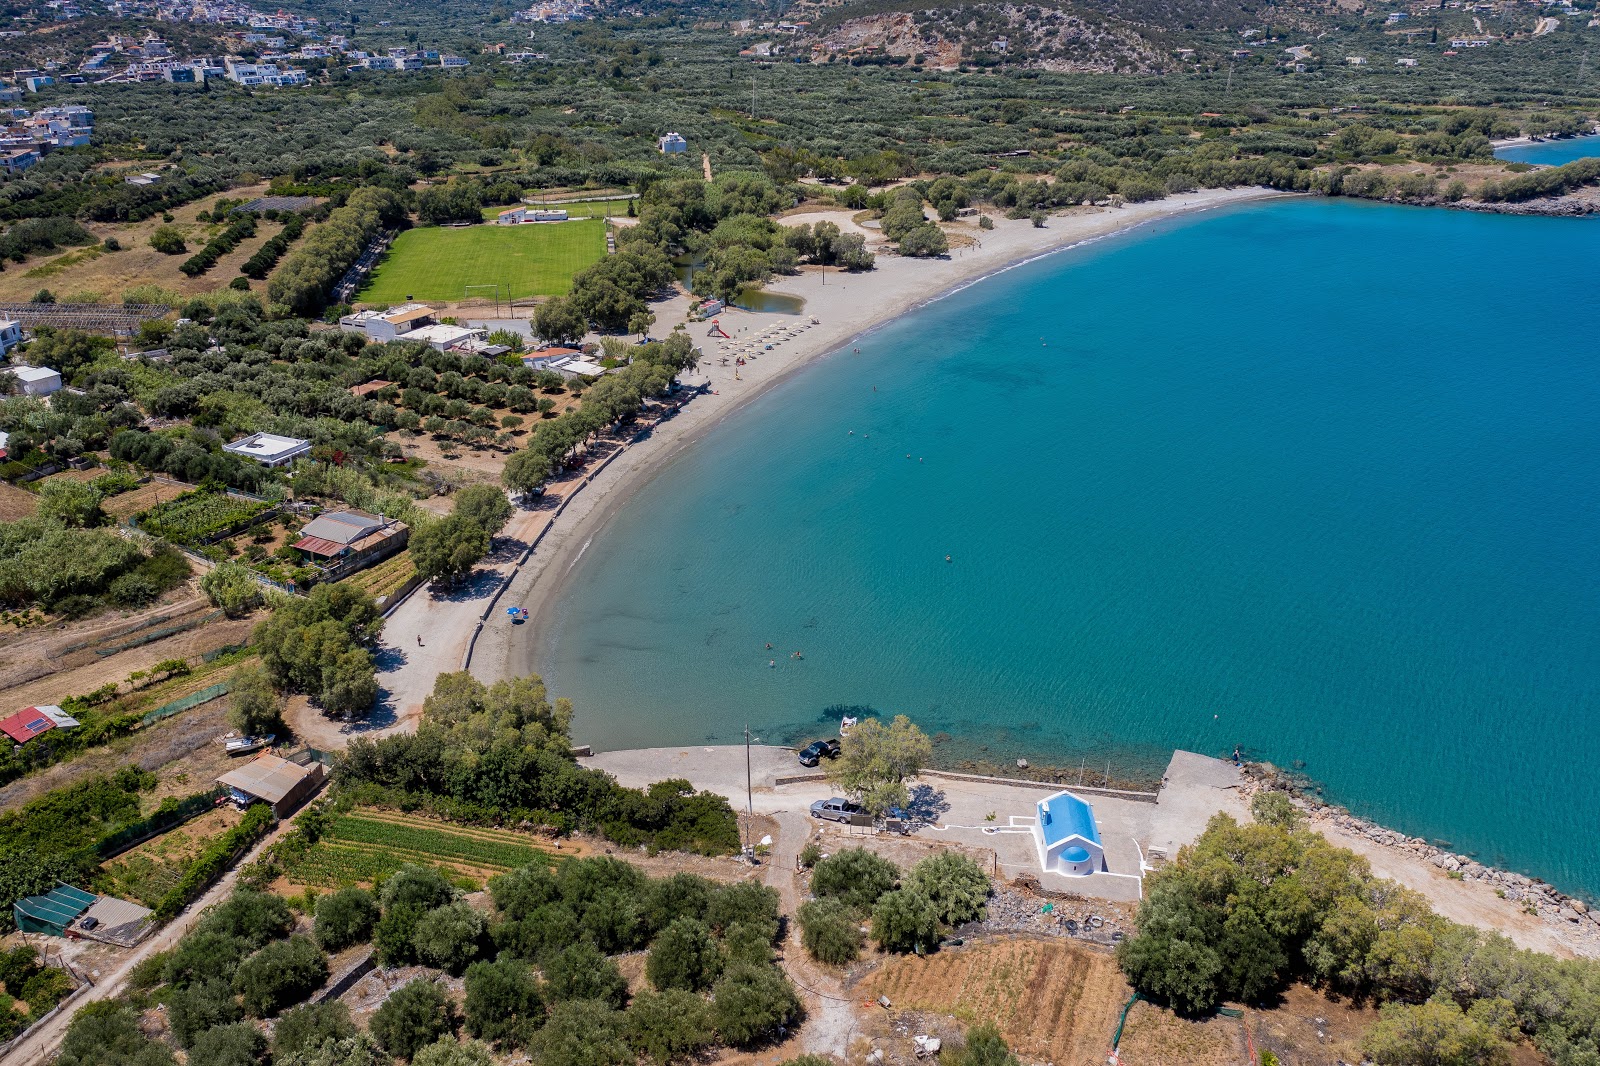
[285,808,555,888]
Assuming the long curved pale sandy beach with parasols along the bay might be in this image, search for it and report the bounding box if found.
[470,189,1285,681]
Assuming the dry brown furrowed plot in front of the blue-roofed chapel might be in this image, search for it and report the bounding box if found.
[859,938,1131,1066]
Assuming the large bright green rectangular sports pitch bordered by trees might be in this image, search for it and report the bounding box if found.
[357,221,605,304]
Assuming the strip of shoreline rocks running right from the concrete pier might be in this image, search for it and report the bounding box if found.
[1243,767,1600,957]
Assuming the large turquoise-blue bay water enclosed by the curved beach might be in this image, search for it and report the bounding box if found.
[536,200,1600,895]
